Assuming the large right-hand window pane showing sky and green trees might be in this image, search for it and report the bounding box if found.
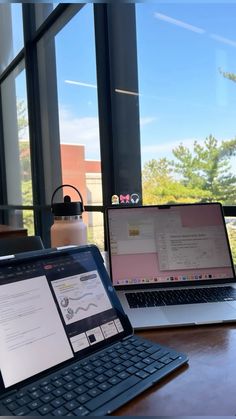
[136,1,236,205]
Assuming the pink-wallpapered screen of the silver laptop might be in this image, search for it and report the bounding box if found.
[106,203,234,288]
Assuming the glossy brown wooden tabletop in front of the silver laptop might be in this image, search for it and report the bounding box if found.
[115,323,236,416]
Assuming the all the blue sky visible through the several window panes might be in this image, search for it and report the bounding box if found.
[11,1,236,171]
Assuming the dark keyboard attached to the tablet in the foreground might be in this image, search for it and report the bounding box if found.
[0,336,187,416]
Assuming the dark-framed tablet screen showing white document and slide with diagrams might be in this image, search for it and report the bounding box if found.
[0,246,130,390]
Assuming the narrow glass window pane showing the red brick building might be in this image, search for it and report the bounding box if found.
[55,5,104,247]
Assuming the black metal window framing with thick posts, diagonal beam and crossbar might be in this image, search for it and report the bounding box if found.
[0,3,236,247]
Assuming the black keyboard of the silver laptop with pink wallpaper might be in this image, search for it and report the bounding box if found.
[125,286,236,308]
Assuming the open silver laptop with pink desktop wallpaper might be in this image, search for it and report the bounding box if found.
[106,203,236,329]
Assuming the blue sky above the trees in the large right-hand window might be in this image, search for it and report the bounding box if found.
[137,4,236,164]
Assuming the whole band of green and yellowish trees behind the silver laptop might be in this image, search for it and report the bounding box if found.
[142,135,236,204]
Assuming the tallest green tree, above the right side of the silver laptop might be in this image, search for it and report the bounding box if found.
[173,135,236,204]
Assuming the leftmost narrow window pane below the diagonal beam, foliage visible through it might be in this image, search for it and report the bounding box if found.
[1,63,33,234]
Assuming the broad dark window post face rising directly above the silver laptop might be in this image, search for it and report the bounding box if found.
[107,3,142,197]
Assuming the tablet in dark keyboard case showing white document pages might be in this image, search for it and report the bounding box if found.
[0,245,187,416]
